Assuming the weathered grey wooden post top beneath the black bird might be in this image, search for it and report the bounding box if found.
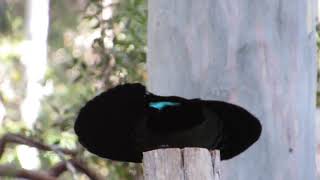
[143,148,220,180]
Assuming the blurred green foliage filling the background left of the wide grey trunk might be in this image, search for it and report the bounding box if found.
[0,0,147,180]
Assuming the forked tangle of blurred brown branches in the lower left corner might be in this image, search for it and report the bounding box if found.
[0,133,104,180]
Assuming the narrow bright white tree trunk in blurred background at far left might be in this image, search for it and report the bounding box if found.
[18,0,49,169]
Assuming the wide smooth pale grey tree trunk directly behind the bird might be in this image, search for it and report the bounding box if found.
[147,0,317,180]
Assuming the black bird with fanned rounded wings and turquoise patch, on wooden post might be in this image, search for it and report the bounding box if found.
[74,83,262,162]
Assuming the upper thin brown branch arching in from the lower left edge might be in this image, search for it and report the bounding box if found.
[0,133,77,158]
